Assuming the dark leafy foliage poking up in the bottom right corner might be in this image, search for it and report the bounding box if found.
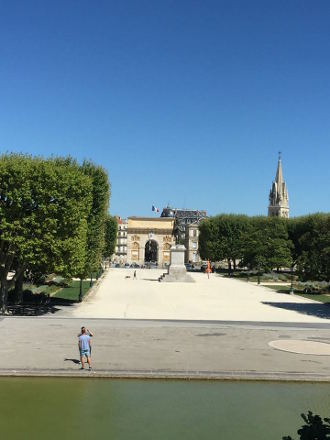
[282,411,330,440]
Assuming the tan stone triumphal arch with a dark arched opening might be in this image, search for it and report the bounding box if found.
[127,217,175,267]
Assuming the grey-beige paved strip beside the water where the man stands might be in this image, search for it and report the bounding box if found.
[0,317,330,381]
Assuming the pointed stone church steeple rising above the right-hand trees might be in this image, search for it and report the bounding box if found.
[268,152,289,218]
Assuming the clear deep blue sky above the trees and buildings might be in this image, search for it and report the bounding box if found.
[0,0,330,217]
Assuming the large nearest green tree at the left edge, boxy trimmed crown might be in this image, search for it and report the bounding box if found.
[0,154,92,313]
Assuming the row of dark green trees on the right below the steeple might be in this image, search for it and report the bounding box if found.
[199,214,330,281]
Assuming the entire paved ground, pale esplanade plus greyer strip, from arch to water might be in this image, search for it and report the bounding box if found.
[0,269,330,382]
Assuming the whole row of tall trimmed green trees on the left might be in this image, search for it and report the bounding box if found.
[0,154,114,313]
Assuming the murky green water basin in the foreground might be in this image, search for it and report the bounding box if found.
[0,373,330,440]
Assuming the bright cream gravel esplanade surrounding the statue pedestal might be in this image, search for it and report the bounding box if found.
[65,269,330,323]
